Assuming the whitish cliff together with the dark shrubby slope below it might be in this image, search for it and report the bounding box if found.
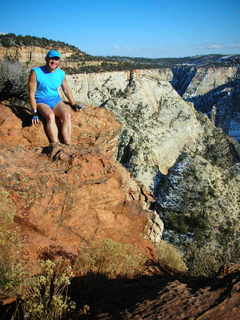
[65,69,240,253]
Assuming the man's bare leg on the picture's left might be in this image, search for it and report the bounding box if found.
[37,103,59,143]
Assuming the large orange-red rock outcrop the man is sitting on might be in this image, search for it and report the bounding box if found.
[0,105,155,272]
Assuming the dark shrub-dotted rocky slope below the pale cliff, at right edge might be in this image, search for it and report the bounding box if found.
[156,114,240,254]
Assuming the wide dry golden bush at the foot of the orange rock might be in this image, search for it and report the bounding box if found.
[74,239,146,278]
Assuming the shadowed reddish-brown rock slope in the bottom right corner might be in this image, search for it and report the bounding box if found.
[84,265,240,320]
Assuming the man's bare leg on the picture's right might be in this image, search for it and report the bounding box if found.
[54,102,72,144]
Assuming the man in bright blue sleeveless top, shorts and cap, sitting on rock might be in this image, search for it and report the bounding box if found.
[28,50,83,144]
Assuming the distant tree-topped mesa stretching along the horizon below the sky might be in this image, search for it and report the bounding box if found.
[0,33,240,74]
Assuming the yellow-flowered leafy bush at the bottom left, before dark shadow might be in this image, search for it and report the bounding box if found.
[23,259,75,320]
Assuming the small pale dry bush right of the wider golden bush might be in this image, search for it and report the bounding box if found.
[156,240,187,272]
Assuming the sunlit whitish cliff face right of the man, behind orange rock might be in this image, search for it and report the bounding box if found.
[68,69,203,189]
